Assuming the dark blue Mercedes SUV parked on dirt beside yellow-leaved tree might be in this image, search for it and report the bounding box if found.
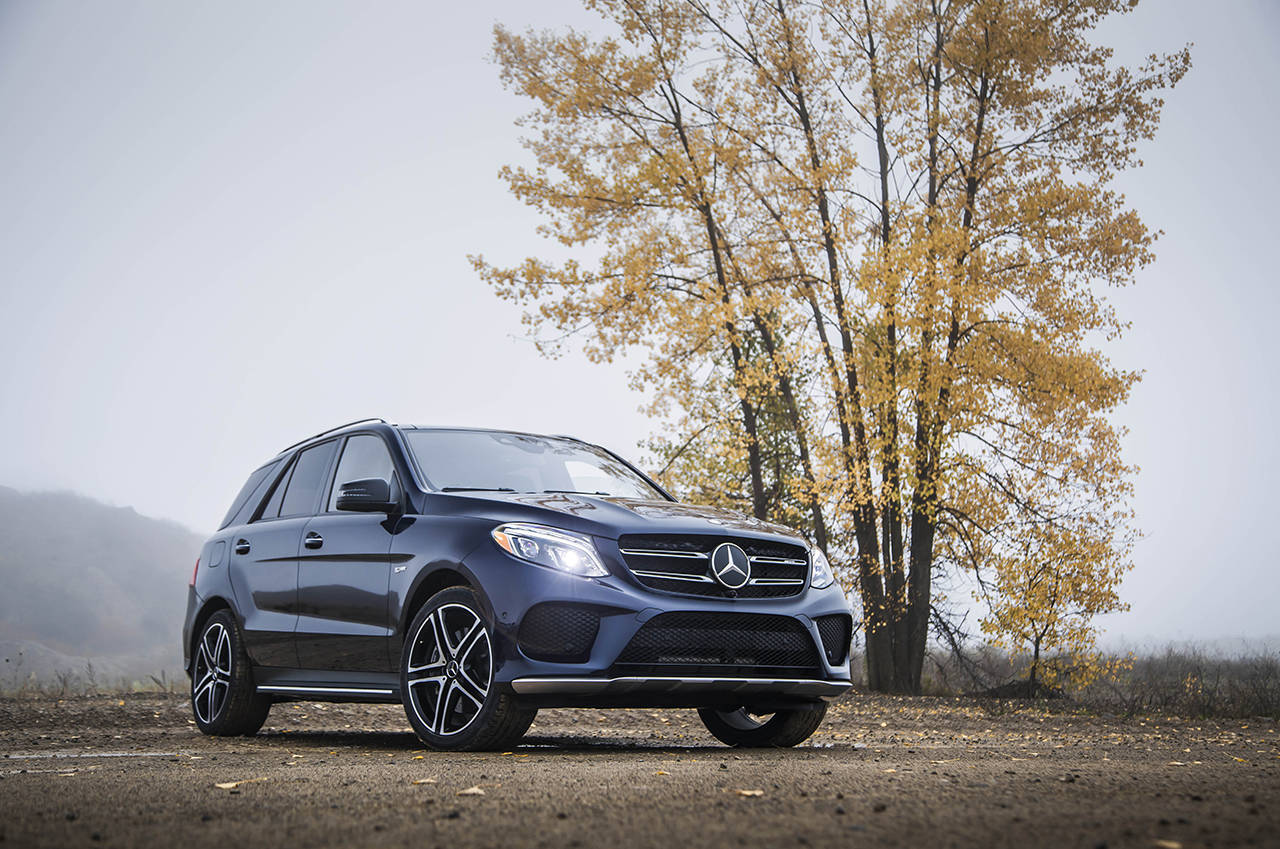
[183,419,852,749]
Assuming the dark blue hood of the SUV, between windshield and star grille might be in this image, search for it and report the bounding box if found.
[430,493,805,544]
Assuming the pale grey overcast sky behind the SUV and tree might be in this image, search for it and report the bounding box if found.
[0,0,1280,642]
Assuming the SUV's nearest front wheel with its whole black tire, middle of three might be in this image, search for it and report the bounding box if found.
[399,586,538,752]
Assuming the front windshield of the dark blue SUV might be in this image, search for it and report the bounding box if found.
[403,430,664,501]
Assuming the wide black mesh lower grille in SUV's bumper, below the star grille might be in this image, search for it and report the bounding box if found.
[614,612,820,677]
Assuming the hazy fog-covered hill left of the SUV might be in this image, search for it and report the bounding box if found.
[0,487,202,681]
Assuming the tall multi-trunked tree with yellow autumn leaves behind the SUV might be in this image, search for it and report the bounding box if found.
[475,0,1189,691]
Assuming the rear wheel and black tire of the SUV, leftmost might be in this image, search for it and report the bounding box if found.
[191,610,271,738]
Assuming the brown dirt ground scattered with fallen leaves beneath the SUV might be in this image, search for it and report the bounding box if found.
[0,695,1280,849]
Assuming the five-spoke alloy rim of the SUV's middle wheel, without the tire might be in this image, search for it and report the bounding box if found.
[404,603,493,736]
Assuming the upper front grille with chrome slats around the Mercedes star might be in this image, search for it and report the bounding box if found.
[618,534,809,598]
